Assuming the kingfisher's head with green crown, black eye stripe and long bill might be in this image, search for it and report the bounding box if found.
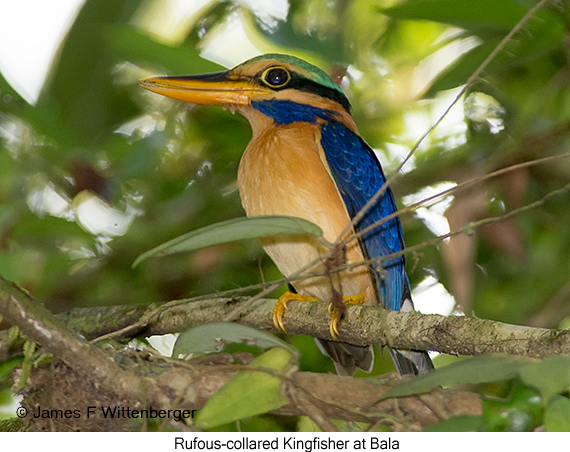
[139,54,350,130]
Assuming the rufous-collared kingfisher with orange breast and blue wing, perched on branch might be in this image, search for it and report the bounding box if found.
[139,53,433,376]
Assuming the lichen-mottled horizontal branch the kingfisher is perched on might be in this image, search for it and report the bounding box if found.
[58,297,570,358]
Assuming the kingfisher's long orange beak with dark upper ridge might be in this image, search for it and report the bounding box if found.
[139,71,271,105]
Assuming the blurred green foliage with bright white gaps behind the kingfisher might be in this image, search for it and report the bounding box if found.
[0,0,570,429]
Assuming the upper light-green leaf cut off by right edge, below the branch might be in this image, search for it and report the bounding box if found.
[521,356,570,401]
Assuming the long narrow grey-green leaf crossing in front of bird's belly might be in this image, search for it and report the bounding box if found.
[133,215,323,267]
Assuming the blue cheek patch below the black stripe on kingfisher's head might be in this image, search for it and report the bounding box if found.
[251,100,335,126]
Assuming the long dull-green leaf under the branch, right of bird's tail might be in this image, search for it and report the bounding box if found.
[382,355,529,400]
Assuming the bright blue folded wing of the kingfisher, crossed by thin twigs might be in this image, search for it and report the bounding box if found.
[321,122,409,311]
